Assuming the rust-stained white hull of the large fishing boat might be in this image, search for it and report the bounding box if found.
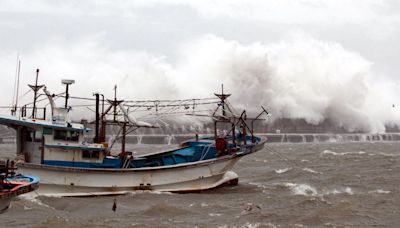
[18,155,241,196]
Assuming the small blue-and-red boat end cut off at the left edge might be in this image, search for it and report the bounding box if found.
[0,161,39,213]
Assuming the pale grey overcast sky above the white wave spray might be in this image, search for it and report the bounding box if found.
[0,0,400,74]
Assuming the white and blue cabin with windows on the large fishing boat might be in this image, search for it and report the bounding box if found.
[0,116,121,168]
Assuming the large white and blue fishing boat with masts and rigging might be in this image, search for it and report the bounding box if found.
[0,71,266,196]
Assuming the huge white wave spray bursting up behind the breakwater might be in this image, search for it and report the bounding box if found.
[0,32,400,133]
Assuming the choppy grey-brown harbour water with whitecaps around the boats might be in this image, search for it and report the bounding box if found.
[0,142,400,228]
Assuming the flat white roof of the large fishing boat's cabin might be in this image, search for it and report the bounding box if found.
[0,115,91,132]
